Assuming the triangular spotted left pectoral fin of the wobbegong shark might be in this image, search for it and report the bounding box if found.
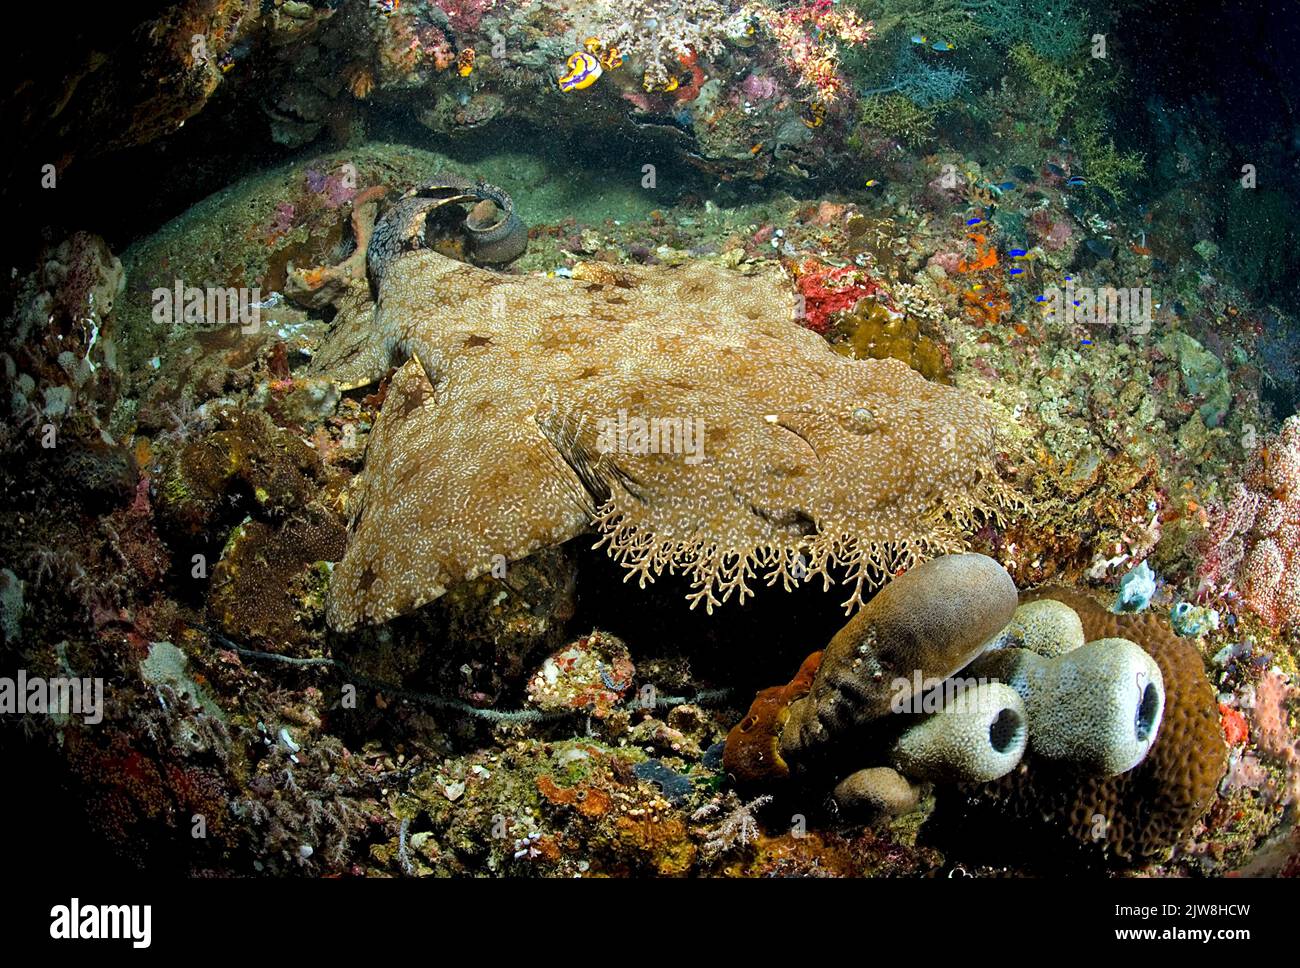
[329,359,592,630]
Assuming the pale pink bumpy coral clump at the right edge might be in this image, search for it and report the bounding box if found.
[1197,414,1300,629]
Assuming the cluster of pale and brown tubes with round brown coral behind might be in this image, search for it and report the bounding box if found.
[725,555,1223,858]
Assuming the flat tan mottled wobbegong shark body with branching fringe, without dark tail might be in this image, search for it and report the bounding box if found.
[319,189,1017,634]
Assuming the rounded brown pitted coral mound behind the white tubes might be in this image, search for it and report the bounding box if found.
[963,587,1227,863]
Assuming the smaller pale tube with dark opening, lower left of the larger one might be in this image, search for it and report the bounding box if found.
[889,682,1028,783]
